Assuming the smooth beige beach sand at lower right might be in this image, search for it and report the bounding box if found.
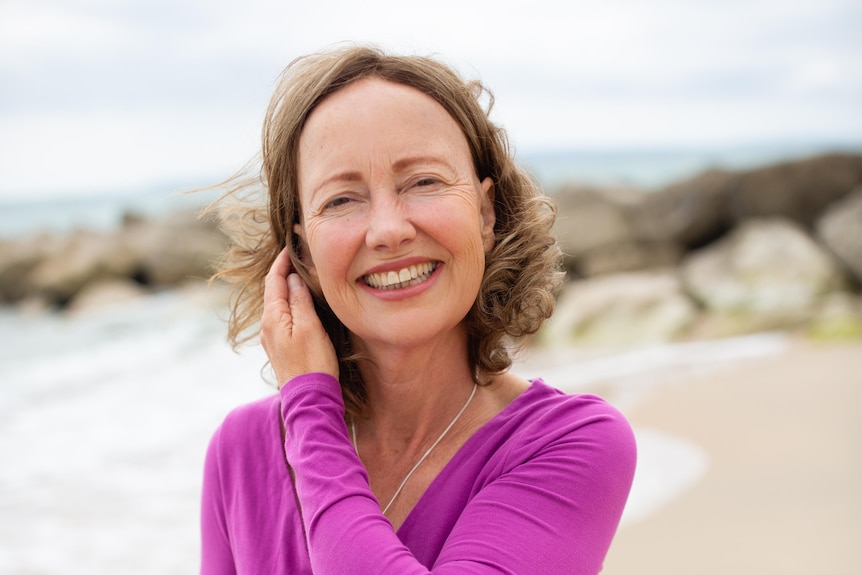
[602,342,862,575]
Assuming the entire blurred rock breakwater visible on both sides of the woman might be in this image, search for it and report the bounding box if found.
[5,150,862,345]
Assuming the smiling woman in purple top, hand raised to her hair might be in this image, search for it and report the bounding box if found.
[202,48,635,575]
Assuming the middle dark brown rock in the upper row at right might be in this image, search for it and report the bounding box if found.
[634,166,739,248]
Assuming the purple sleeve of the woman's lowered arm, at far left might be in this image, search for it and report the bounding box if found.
[201,395,312,575]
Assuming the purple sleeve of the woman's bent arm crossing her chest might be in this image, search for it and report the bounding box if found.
[281,374,635,575]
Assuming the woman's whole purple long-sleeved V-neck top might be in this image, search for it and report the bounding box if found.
[201,374,635,575]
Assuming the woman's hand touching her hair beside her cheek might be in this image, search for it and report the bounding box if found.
[260,249,338,388]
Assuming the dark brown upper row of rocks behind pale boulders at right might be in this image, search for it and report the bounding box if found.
[554,154,862,277]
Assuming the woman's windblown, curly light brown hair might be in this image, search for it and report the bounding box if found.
[211,46,563,416]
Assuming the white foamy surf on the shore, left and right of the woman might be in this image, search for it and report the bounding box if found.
[0,291,785,575]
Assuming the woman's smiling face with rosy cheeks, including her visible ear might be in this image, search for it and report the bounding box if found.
[296,78,494,347]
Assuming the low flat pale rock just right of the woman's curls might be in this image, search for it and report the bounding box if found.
[539,270,698,345]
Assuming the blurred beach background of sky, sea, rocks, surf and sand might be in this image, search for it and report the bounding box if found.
[0,0,862,574]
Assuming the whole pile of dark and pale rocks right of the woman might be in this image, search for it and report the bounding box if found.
[543,154,862,344]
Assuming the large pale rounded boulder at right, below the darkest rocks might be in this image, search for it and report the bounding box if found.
[682,219,844,318]
